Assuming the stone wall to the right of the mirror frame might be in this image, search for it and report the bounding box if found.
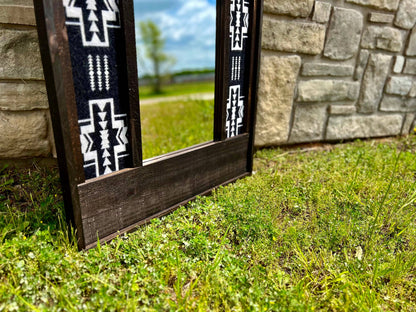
[256,0,416,146]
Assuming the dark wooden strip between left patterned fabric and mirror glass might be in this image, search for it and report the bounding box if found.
[120,1,143,167]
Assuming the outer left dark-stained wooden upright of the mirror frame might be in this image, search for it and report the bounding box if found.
[34,0,85,249]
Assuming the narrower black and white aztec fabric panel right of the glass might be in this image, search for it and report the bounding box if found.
[225,0,251,138]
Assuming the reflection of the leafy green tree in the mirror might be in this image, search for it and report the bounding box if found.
[139,20,176,93]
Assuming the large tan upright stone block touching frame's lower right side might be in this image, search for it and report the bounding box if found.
[255,53,301,146]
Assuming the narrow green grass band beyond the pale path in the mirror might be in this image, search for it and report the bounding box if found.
[139,81,215,99]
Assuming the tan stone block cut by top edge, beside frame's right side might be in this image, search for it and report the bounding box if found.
[264,0,314,17]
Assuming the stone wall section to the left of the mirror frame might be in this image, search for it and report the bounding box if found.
[0,0,54,159]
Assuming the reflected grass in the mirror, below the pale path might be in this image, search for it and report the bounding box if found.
[140,100,214,159]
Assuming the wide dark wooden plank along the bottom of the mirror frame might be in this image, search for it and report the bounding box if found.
[78,135,249,245]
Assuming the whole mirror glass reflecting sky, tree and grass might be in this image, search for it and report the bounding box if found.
[134,0,216,159]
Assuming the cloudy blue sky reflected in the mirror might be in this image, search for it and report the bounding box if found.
[134,0,216,76]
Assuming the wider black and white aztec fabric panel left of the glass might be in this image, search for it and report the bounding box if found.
[63,0,132,179]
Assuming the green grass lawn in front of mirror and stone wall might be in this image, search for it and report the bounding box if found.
[0,136,416,311]
